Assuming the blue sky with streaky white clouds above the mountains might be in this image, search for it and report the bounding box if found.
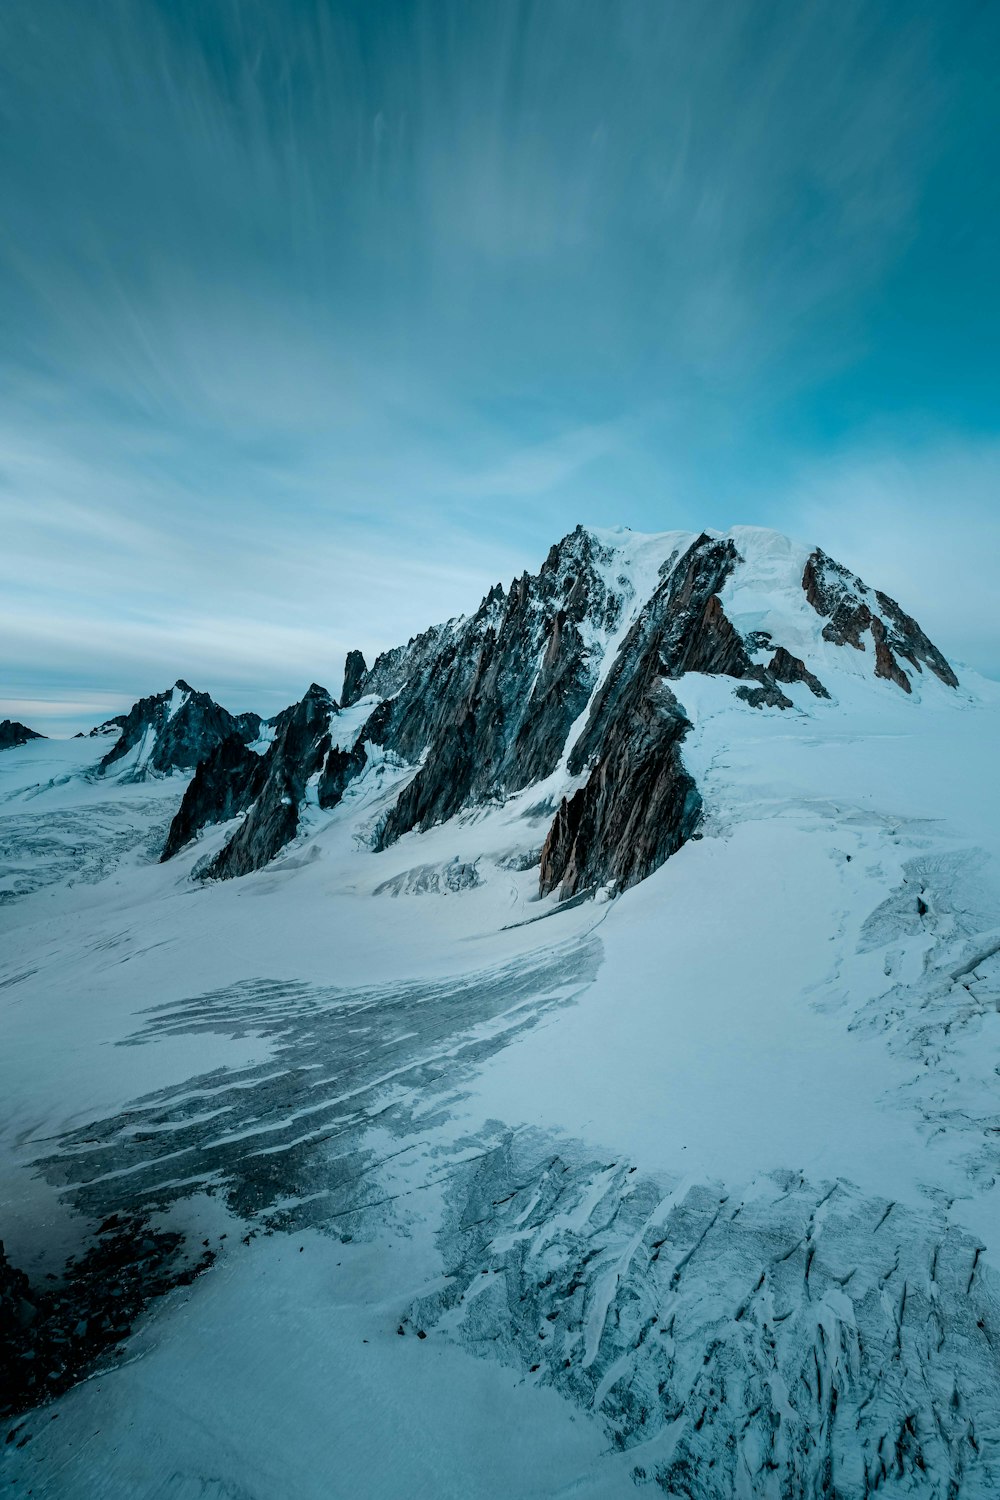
[0,0,1000,732]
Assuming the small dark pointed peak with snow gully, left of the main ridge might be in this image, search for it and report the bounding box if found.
[100,681,261,779]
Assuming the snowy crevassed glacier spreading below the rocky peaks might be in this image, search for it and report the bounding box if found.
[0,666,1000,1500]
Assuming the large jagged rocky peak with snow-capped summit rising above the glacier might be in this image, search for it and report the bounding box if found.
[156,527,958,899]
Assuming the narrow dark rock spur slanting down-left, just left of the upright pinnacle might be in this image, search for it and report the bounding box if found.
[200,683,337,879]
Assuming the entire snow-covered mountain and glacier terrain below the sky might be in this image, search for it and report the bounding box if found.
[0,528,1000,1500]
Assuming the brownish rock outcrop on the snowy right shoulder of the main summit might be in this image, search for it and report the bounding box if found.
[802,548,958,693]
